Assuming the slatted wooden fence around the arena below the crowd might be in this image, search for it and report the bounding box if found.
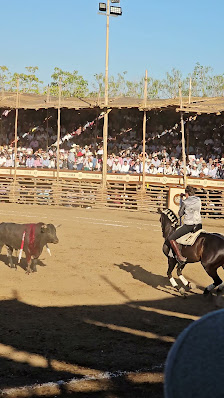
[0,174,224,218]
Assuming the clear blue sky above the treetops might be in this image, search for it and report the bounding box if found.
[0,0,224,84]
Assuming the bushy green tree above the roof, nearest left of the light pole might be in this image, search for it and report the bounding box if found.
[50,67,88,97]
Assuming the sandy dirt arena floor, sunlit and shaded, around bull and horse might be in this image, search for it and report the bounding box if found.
[0,203,224,398]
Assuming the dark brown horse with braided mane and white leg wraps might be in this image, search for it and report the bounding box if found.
[158,209,224,294]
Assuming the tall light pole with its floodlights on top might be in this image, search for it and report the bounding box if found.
[99,0,122,189]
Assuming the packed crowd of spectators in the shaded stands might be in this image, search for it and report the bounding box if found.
[0,107,224,179]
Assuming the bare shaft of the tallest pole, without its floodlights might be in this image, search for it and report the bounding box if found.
[102,0,110,189]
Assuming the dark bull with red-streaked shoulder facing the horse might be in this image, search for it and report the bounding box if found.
[0,222,58,273]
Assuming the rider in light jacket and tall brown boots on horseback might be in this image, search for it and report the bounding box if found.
[165,185,202,265]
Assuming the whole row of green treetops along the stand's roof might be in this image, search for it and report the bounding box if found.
[0,63,224,99]
